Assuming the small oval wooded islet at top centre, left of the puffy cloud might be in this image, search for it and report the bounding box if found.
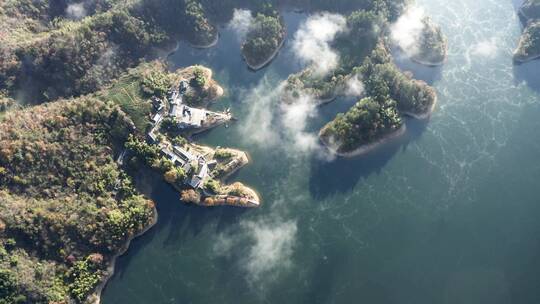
[238,9,286,70]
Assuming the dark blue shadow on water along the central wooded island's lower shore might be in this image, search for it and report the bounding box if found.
[309,119,429,199]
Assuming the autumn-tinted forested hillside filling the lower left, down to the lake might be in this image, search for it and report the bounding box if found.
[0,97,155,303]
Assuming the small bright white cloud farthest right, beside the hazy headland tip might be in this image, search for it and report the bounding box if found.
[390,6,426,57]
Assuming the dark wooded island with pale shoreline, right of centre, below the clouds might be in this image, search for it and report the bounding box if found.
[319,40,437,157]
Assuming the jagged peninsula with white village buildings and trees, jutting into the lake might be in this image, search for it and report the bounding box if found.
[126,66,260,207]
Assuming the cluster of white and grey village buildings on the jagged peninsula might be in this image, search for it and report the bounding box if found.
[148,81,231,189]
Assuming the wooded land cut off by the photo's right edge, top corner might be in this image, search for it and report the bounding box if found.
[514,0,540,64]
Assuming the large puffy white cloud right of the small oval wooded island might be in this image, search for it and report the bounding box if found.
[293,13,347,75]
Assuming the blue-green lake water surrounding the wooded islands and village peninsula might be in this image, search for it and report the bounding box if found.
[102,0,540,304]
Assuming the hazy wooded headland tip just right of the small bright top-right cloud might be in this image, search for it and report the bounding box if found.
[411,17,448,66]
